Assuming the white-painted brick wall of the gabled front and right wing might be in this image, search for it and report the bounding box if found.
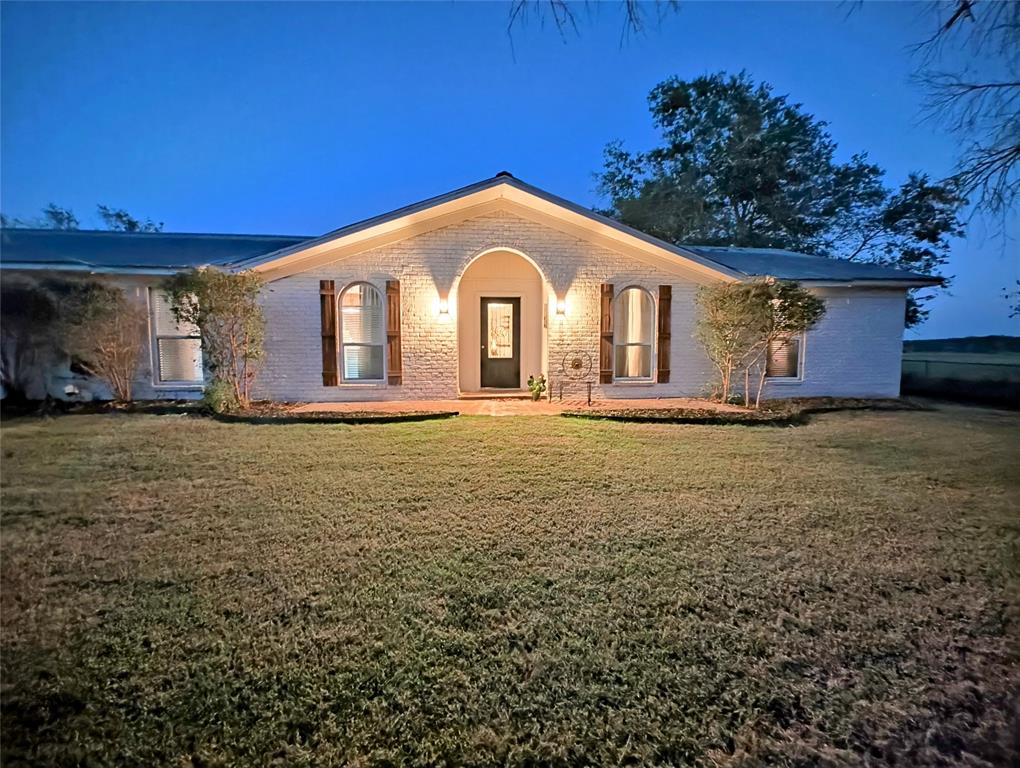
[256,212,905,402]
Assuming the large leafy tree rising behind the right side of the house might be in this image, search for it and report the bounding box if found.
[599,73,964,324]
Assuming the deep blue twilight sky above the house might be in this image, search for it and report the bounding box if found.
[0,0,1020,337]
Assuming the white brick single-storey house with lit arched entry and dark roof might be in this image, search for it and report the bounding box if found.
[0,173,937,402]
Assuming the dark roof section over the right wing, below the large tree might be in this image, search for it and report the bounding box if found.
[681,245,932,281]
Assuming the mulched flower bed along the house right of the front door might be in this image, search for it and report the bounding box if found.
[563,398,932,426]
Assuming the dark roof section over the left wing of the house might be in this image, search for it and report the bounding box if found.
[0,229,307,272]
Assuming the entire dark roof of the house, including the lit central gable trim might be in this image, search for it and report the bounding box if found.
[0,171,941,288]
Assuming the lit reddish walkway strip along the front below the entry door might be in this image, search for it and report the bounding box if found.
[291,398,743,416]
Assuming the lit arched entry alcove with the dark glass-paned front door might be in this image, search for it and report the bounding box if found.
[457,248,546,393]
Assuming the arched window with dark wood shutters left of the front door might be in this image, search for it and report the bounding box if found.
[340,283,386,381]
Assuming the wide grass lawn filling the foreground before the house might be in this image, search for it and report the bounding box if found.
[0,407,1020,766]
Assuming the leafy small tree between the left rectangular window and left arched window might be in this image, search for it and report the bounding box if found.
[164,267,265,408]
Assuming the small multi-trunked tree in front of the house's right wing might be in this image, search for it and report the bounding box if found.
[695,279,825,408]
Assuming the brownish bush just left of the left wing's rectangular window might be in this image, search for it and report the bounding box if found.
[63,283,146,402]
